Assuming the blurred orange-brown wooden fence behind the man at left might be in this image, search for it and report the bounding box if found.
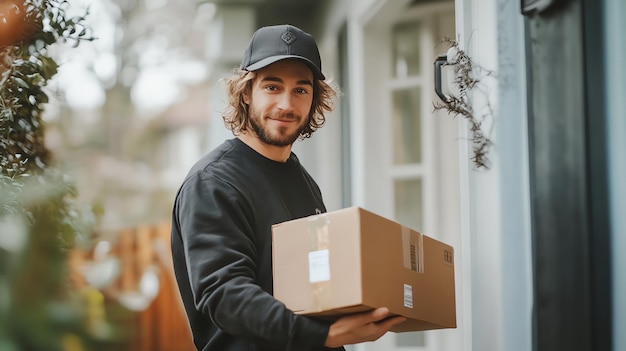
[70,223,195,351]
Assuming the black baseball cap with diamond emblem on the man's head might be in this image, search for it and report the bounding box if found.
[241,24,326,80]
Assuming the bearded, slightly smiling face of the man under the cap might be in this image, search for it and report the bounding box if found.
[244,59,313,146]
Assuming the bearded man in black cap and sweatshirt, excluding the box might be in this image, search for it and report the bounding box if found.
[172,25,404,351]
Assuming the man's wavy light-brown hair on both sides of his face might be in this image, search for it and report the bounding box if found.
[222,68,337,139]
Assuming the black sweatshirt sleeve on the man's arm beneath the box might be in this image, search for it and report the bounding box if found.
[175,171,329,351]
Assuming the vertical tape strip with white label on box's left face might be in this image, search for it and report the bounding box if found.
[307,213,330,312]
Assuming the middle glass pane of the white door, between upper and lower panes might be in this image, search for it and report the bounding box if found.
[392,87,422,165]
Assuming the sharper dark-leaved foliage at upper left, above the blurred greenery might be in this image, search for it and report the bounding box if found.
[0,0,93,177]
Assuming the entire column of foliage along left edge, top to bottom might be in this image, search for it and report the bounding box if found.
[0,0,114,350]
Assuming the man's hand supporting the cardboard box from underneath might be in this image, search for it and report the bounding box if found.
[324,307,406,348]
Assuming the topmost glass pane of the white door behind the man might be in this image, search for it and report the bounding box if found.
[392,22,420,78]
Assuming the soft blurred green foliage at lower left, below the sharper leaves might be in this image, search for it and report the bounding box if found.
[0,168,93,350]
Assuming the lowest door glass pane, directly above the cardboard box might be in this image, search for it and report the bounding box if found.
[394,179,423,231]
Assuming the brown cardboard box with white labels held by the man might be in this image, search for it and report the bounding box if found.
[272,207,456,332]
